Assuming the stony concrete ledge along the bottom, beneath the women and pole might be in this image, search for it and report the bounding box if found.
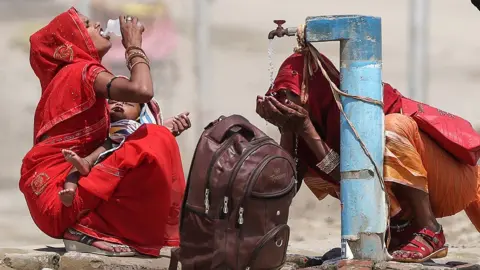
[0,245,480,270]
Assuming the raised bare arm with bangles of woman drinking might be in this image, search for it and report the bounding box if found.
[94,16,153,103]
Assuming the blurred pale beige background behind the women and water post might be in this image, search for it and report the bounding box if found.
[0,0,480,252]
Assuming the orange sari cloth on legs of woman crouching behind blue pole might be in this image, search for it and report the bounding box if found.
[304,114,480,225]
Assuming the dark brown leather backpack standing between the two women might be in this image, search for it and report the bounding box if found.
[170,115,296,270]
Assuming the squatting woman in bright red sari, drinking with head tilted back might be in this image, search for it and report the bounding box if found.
[20,8,185,256]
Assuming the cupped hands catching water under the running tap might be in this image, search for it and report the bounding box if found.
[256,96,311,133]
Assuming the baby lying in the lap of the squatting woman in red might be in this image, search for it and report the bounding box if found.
[59,100,190,207]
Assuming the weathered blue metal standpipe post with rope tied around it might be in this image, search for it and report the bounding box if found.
[306,15,389,261]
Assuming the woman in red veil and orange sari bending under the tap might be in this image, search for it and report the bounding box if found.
[257,52,480,262]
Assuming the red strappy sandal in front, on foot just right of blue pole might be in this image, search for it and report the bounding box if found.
[392,227,448,263]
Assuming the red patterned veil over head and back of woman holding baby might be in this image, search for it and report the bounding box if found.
[30,8,105,143]
